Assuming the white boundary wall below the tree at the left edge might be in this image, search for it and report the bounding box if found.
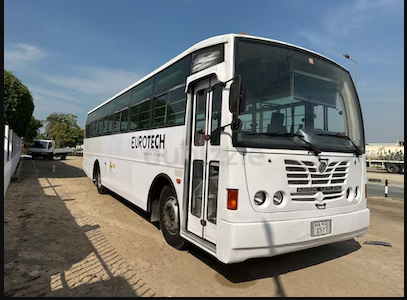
[4,125,22,196]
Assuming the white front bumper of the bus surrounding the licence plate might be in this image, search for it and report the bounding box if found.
[216,208,370,263]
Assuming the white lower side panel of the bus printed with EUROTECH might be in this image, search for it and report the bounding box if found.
[83,126,185,210]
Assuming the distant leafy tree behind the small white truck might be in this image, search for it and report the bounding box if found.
[45,112,84,147]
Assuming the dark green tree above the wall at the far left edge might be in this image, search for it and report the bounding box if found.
[4,70,34,137]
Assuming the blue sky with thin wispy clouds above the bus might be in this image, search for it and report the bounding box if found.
[4,0,404,142]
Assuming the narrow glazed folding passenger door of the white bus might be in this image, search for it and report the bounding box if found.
[187,79,222,244]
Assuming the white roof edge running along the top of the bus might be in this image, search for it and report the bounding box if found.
[87,33,349,115]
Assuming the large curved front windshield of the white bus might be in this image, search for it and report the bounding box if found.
[233,38,365,153]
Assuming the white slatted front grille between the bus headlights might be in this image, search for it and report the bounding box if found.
[285,160,349,201]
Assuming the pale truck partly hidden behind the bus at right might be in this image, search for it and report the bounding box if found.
[366,141,404,174]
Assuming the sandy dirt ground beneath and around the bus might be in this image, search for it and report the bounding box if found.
[4,157,404,297]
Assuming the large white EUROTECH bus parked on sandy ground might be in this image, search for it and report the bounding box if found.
[83,34,370,264]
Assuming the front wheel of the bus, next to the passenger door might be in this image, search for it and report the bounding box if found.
[160,186,186,250]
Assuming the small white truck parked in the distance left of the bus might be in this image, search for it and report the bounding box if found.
[27,139,73,160]
